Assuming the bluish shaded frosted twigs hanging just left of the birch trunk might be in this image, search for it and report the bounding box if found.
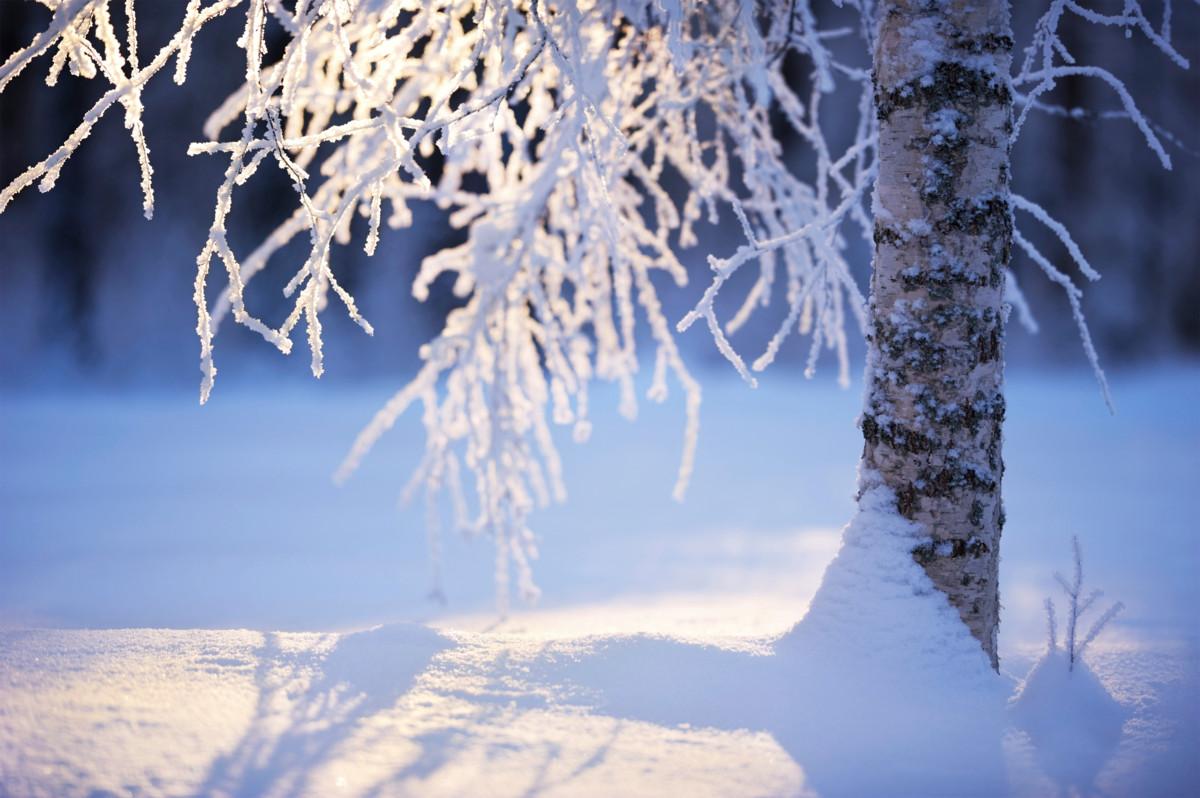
[678,2,876,386]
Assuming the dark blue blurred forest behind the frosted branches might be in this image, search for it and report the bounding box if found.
[0,0,1200,396]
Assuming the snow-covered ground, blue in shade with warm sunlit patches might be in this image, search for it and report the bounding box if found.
[0,366,1200,796]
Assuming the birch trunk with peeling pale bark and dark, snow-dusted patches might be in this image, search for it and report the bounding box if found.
[862,0,1013,667]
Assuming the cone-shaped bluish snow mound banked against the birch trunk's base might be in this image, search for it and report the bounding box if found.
[774,475,1013,796]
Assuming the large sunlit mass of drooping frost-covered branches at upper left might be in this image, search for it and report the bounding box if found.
[9,0,739,596]
